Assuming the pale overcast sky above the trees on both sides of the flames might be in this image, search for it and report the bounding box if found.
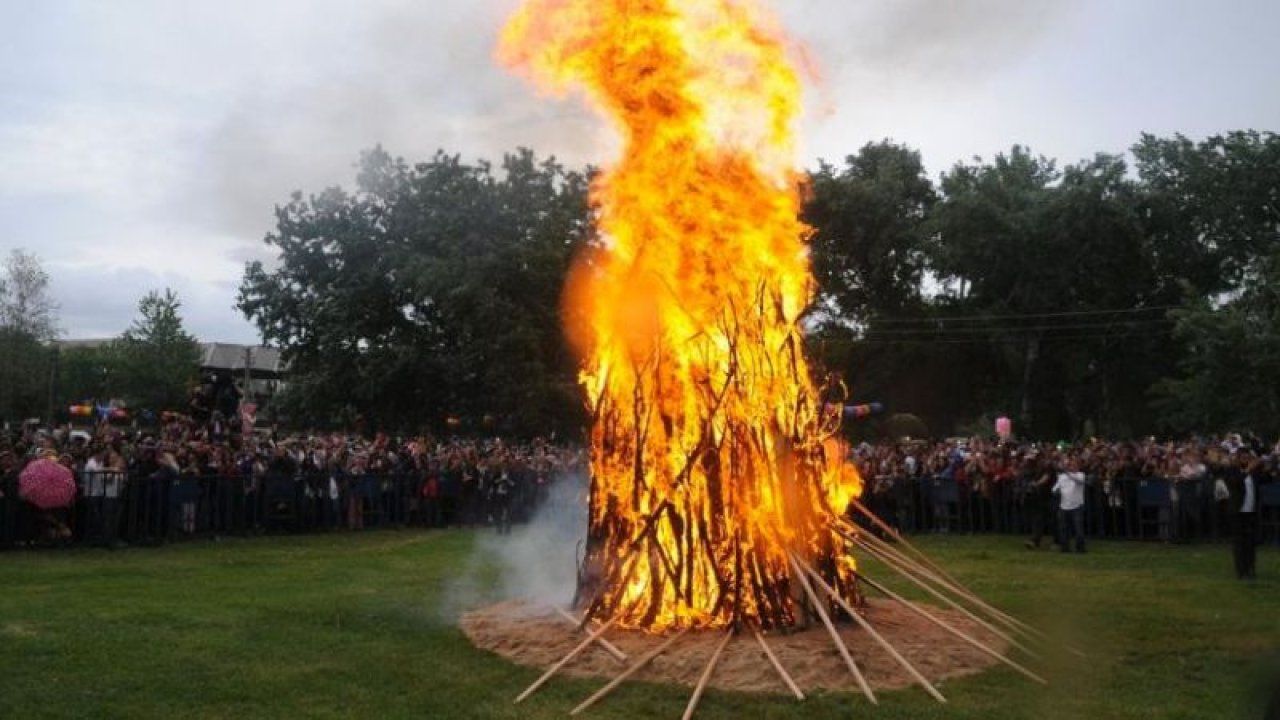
[0,0,1280,342]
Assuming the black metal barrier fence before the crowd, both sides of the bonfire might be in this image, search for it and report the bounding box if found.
[0,473,1280,548]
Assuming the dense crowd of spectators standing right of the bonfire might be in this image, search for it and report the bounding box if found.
[852,433,1280,577]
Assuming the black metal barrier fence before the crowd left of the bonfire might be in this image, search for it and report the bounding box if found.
[0,473,548,548]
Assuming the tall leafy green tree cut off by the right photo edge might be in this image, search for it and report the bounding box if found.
[1133,131,1280,433]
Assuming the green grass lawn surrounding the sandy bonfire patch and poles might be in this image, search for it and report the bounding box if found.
[0,530,1280,720]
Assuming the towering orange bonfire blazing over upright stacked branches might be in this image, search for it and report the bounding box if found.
[499,0,861,630]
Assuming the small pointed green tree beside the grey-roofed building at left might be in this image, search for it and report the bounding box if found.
[113,288,200,411]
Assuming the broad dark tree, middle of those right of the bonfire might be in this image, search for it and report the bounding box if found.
[921,146,1178,437]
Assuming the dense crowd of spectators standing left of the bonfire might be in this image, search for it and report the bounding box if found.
[0,415,585,546]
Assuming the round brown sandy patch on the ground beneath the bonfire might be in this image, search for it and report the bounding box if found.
[461,601,1007,693]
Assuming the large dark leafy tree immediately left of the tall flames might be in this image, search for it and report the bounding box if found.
[238,149,591,433]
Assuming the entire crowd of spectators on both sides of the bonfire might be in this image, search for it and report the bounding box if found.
[0,414,1280,575]
